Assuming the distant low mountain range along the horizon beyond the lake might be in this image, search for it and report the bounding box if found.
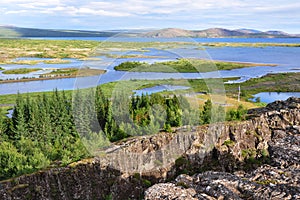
[0,26,300,38]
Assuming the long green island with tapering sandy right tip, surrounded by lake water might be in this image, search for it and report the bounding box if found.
[115,59,275,73]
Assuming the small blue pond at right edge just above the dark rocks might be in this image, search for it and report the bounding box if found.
[251,92,300,103]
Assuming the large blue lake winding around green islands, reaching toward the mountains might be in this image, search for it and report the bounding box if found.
[0,38,300,94]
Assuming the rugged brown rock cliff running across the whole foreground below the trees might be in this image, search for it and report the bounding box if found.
[0,98,300,199]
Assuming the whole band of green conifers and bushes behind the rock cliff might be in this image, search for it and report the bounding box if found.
[0,87,245,179]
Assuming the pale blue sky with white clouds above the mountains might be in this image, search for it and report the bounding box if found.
[0,0,300,33]
